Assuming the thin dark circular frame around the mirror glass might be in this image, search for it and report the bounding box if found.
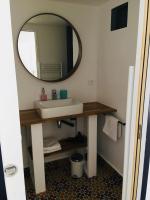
[17,13,82,82]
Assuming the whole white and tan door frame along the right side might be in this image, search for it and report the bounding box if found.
[122,0,150,200]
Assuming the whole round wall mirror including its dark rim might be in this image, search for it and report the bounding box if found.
[18,13,82,82]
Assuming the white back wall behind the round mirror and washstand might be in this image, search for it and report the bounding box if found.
[11,0,98,166]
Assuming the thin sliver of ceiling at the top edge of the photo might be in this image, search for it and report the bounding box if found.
[52,0,108,6]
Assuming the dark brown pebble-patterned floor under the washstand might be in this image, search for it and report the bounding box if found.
[25,159,122,200]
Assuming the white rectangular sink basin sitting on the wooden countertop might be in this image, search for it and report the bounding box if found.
[35,98,83,119]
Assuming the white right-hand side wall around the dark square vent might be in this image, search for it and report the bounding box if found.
[98,0,139,174]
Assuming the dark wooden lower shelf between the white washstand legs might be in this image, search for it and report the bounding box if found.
[28,137,87,160]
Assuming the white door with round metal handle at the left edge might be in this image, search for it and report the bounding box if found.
[0,0,26,200]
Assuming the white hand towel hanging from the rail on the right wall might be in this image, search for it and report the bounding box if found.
[103,115,119,142]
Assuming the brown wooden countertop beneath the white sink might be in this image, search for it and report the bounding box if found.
[20,102,117,125]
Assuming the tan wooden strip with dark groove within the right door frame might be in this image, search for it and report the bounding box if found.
[131,0,150,200]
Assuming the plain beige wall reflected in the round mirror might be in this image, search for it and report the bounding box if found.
[23,23,67,69]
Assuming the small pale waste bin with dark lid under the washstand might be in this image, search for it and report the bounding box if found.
[71,153,84,178]
